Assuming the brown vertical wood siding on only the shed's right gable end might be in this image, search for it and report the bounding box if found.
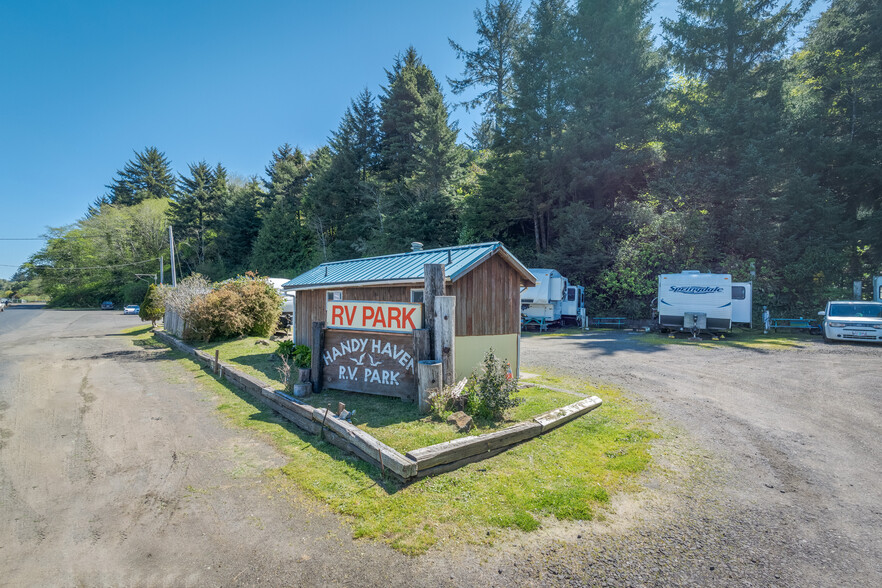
[447,255,521,337]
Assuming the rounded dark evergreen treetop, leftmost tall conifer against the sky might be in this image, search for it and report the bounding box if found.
[107,147,175,206]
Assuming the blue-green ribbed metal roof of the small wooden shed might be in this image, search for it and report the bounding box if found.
[282,241,536,290]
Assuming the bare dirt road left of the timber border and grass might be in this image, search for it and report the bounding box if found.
[0,307,464,587]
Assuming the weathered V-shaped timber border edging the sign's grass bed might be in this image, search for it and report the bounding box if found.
[153,330,603,482]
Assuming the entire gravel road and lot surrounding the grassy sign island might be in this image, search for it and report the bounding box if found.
[0,306,882,586]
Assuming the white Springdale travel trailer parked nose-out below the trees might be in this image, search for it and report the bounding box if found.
[656,270,753,334]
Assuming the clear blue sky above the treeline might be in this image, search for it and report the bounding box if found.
[0,0,828,278]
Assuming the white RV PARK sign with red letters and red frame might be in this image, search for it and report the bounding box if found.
[325,300,423,333]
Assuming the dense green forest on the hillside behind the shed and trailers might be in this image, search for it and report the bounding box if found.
[7,0,882,318]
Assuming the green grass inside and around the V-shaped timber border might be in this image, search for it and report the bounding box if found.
[128,327,657,554]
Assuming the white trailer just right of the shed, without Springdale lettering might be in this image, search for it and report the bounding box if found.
[521,269,585,325]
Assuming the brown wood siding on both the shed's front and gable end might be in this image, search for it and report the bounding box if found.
[294,255,521,345]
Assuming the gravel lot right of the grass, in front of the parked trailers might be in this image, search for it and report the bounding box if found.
[522,333,882,586]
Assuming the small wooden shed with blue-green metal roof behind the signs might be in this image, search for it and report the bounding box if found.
[283,242,536,379]
